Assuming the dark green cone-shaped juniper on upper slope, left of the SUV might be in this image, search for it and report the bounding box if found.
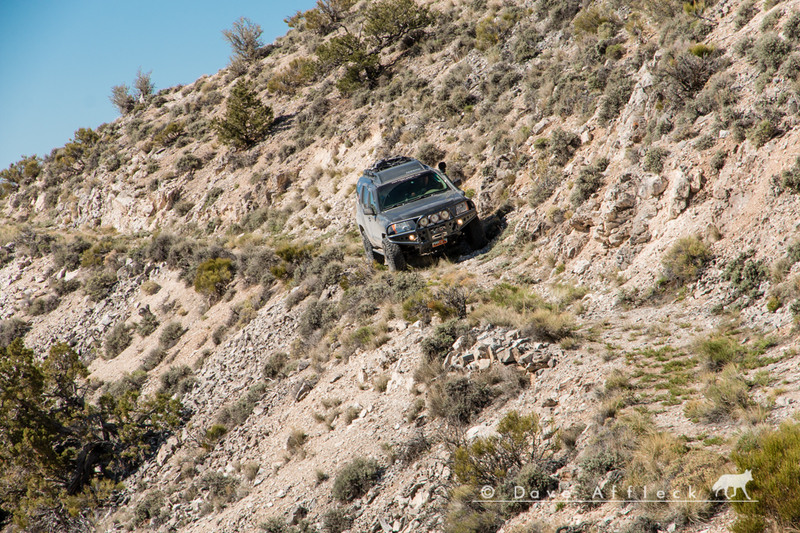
[213,80,273,149]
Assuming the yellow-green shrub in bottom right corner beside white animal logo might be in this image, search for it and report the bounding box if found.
[731,422,800,533]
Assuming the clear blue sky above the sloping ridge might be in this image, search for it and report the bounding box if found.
[0,0,315,169]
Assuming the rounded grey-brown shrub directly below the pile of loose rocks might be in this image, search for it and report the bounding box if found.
[428,376,494,424]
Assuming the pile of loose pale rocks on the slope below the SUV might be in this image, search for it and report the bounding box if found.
[445,329,563,374]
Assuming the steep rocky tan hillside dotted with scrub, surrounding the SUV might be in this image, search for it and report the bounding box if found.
[0,0,800,533]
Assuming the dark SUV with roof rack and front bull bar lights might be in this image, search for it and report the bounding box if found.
[356,157,486,270]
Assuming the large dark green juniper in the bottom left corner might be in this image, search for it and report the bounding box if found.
[0,339,181,528]
